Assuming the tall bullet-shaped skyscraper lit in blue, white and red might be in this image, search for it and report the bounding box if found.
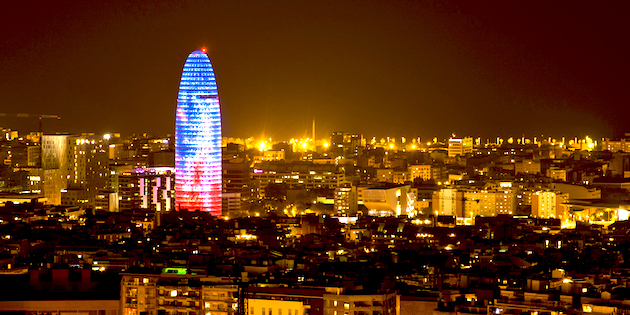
[175,50,221,216]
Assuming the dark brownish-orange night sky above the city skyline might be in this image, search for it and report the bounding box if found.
[0,0,630,139]
